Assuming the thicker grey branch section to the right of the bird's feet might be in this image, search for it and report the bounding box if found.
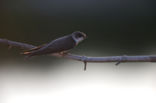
[64,54,156,63]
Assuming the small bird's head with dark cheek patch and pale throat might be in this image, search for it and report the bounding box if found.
[71,31,87,45]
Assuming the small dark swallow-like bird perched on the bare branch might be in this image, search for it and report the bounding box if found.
[23,31,87,57]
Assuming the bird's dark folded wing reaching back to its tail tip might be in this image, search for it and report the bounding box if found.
[24,36,75,57]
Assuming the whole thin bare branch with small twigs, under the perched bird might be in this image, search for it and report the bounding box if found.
[0,39,156,63]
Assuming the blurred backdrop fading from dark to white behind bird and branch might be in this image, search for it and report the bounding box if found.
[0,0,156,103]
